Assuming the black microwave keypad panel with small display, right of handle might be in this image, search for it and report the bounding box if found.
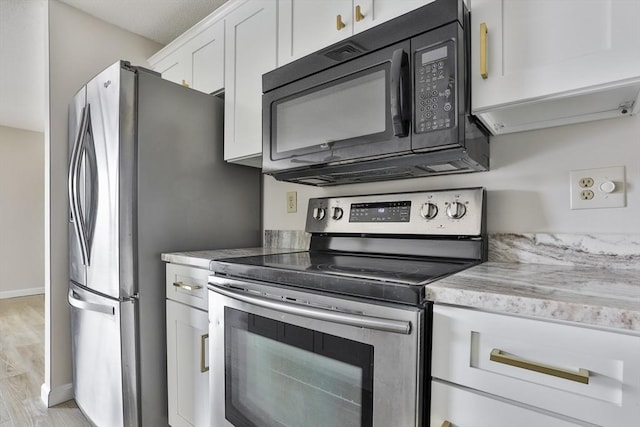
[413,41,456,133]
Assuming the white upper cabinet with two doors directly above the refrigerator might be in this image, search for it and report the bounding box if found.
[149,20,224,93]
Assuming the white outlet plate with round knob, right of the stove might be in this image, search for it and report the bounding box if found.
[569,166,627,209]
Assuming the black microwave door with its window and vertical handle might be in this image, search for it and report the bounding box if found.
[262,41,411,173]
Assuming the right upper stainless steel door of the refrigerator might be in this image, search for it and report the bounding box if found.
[86,62,135,299]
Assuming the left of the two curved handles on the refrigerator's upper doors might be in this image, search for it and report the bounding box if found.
[68,105,89,265]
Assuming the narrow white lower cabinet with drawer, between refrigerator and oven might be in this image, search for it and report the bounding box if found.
[166,264,210,427]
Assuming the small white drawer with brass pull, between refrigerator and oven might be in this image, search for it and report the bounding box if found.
[166,264,210,311]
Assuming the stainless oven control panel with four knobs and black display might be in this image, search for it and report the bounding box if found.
[305,187,486,236]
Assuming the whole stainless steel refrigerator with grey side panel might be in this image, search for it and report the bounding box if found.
[68,61,261,427]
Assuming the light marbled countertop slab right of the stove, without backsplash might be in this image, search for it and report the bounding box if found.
[426,262,640,334]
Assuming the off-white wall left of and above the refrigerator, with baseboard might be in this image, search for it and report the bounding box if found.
[42,0,162,405]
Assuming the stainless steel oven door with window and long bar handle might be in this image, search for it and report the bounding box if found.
[209,276,428,427]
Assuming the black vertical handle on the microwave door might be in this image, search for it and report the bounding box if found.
[389,49,410,136]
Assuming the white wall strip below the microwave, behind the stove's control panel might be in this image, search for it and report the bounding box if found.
[264,116,640,233]
